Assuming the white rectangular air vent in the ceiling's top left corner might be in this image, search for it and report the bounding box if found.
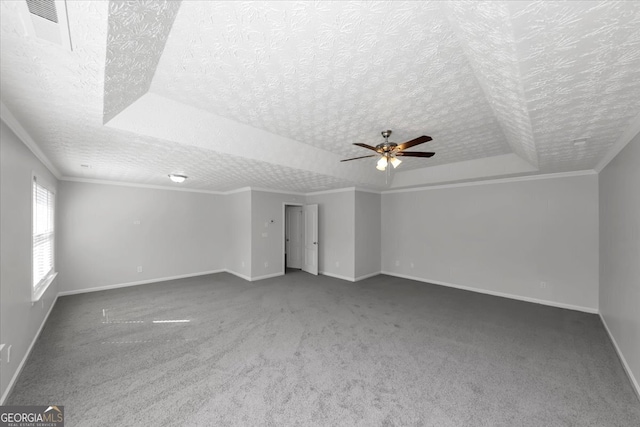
[19,0,73,50]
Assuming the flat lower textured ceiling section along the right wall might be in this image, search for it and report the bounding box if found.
[509,1,640,172]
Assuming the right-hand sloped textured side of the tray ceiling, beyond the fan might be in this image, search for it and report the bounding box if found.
[442,1,538,168]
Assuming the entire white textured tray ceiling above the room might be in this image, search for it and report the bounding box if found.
[0,0,640,192]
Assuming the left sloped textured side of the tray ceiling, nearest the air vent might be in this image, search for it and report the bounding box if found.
[103,0,181,123]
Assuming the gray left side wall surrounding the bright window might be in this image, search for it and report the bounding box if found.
[0,122,60,402]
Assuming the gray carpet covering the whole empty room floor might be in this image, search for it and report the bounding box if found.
[7,272,640,426]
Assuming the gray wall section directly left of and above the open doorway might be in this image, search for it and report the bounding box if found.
[251,190,304,279]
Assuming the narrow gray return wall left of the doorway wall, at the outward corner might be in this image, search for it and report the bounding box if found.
[226,190,251,280]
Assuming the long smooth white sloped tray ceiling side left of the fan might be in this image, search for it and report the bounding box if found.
[107,92,385,187]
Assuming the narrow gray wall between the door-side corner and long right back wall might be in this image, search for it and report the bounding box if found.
[355,191,382,279]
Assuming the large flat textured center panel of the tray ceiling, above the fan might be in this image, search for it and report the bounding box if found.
[151,2,511,162]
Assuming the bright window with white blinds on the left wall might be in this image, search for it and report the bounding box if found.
[31,176,55,301]
